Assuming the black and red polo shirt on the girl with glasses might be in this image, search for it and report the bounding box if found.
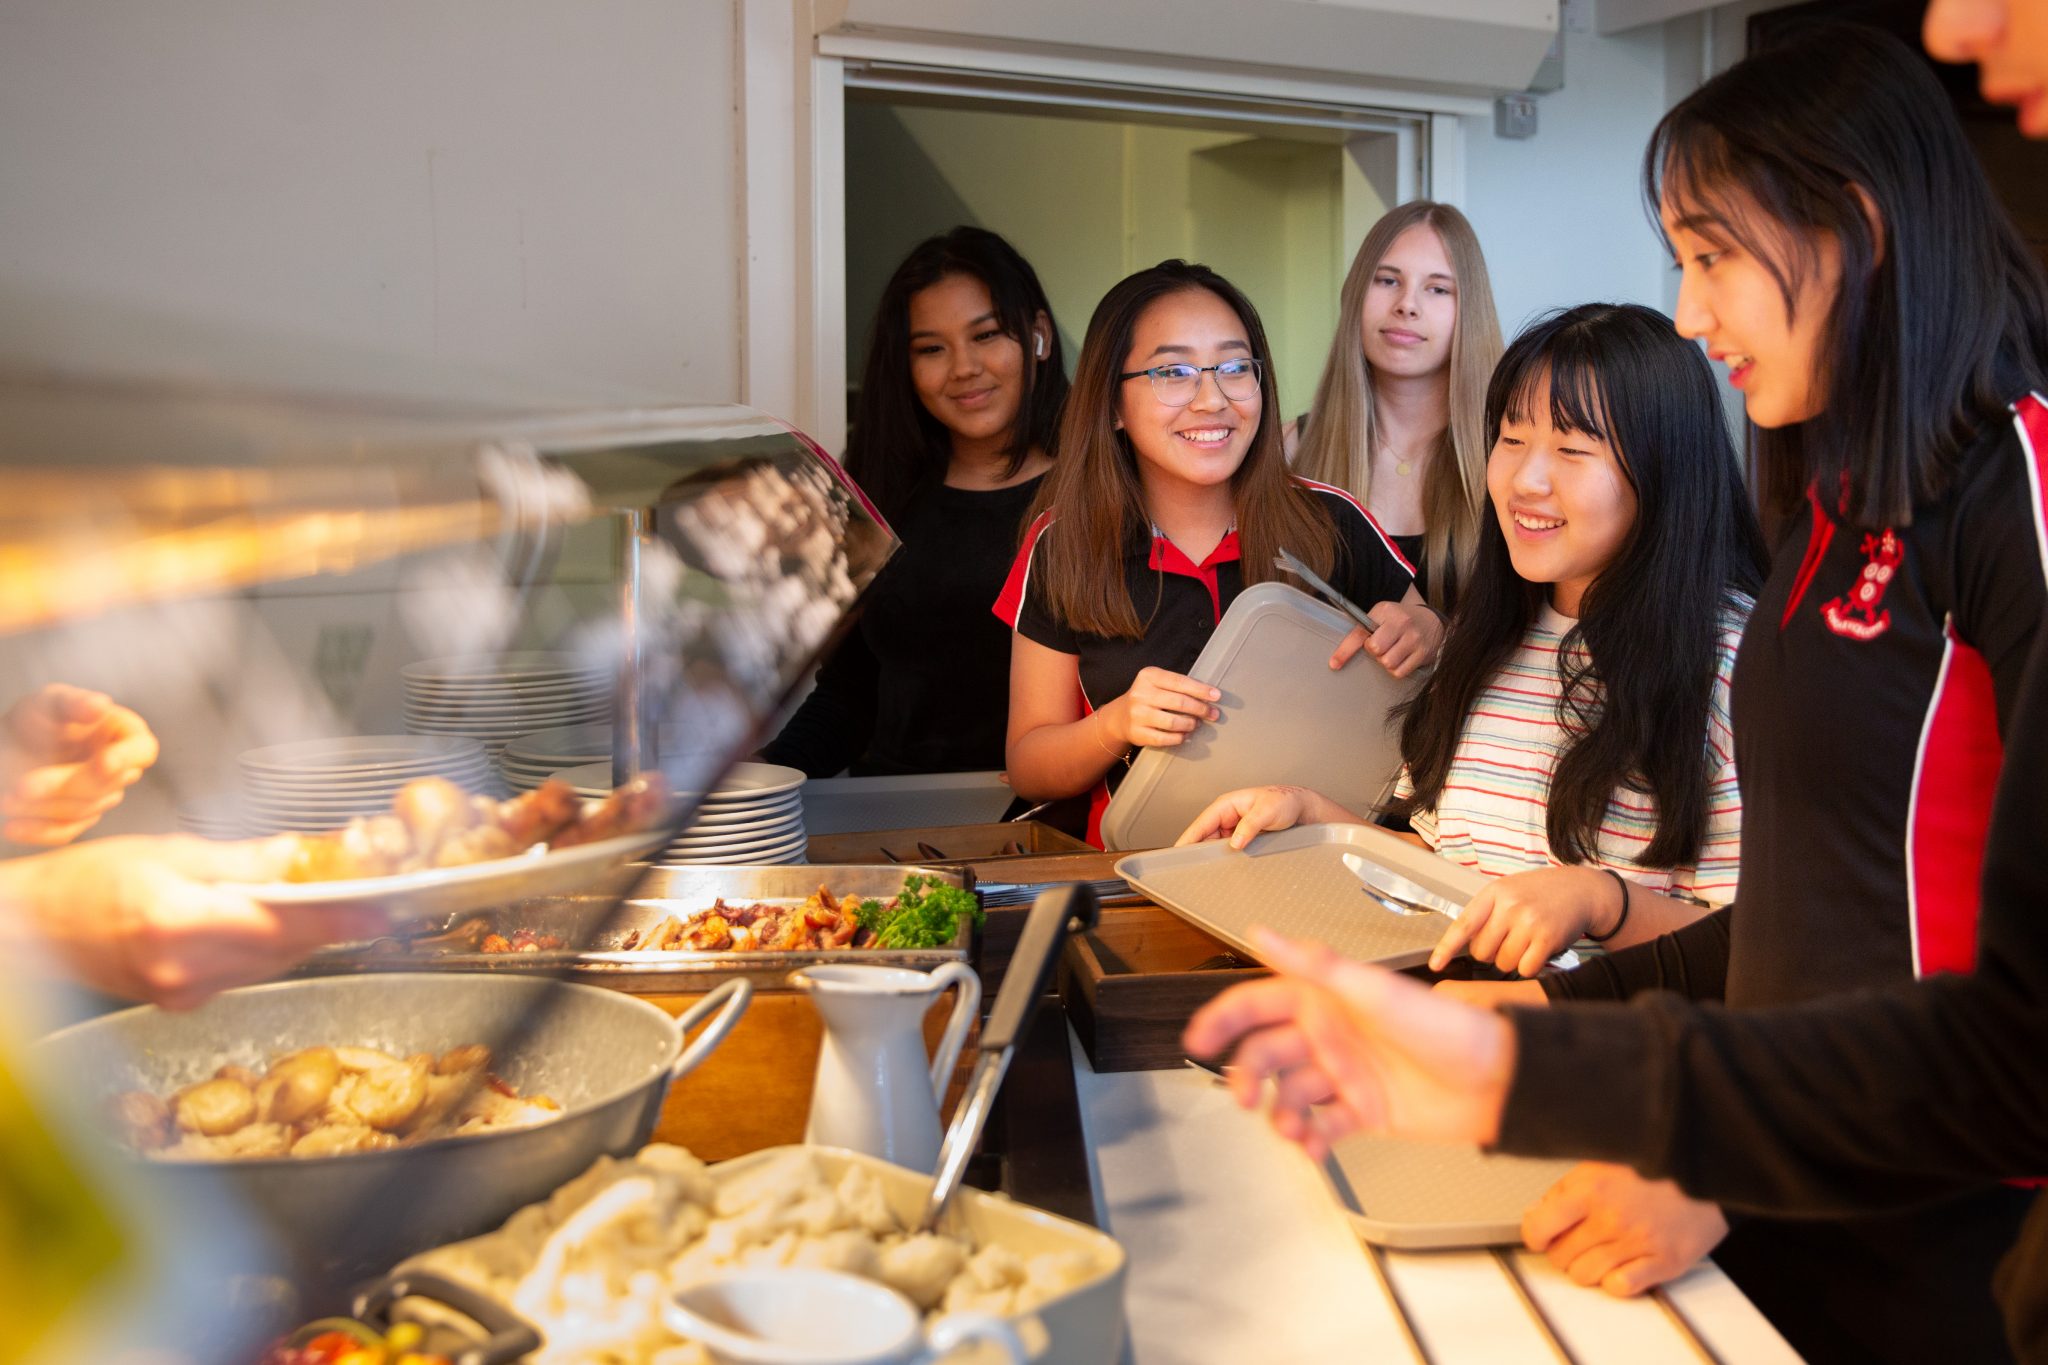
[995,479,1415,847]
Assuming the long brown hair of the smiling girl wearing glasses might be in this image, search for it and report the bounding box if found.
[1028,260,1337,639]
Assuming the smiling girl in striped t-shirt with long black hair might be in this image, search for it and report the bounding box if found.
[1182,303,1763,976]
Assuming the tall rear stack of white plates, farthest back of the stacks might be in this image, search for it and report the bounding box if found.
[399,653,612,759]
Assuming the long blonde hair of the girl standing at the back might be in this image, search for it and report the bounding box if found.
[1294,199,1501,612]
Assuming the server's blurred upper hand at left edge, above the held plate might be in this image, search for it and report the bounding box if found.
[0,684,158,847]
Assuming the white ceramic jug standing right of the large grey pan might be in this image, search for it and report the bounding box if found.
[788,962,981,1171]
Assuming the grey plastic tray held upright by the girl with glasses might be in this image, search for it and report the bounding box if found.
[1102,583,1419,849]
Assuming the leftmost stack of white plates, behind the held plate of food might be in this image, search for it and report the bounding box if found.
[240,735,496,835]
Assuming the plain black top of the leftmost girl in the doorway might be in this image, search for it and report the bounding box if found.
[762,479,1038,778]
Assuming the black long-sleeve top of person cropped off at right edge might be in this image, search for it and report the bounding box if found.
[1499,401,2048,1359]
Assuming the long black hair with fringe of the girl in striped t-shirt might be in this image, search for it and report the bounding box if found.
[1395,303,1763,868]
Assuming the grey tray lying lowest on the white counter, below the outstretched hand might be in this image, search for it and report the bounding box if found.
[1323,1138,1577,1250]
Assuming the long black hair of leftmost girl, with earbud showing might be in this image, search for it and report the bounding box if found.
[846,227,1067,520]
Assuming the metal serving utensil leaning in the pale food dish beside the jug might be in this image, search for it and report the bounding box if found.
[918,882,1102,1232]
